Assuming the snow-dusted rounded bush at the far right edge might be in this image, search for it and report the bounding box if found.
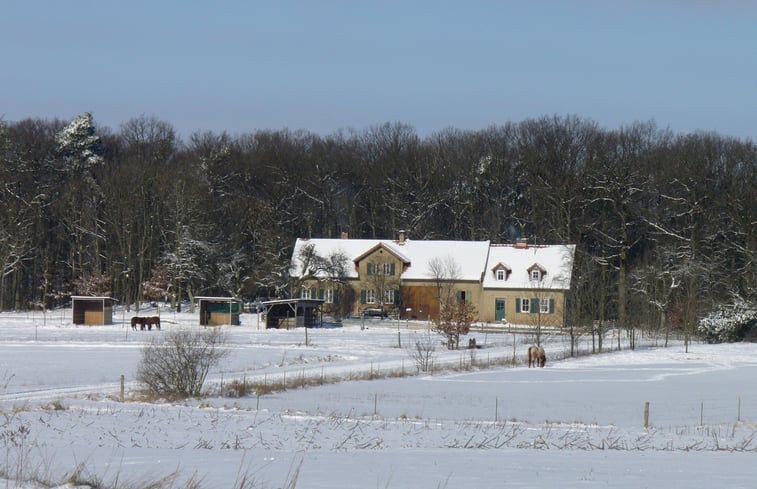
[698,299,757,343]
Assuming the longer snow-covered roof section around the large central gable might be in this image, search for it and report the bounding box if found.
[290,238,489,282]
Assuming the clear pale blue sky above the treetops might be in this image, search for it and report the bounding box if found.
[0,0,757,141]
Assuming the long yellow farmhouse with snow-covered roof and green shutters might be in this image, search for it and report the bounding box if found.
[290,233,575,326]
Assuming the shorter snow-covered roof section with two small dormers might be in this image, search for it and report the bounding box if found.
[482,244,576,289]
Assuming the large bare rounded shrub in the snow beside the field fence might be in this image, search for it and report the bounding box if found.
[137,329,228,397]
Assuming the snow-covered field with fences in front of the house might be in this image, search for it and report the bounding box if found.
[0,310,757,489]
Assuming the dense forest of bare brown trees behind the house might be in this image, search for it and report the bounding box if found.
[0,114,757,338]
